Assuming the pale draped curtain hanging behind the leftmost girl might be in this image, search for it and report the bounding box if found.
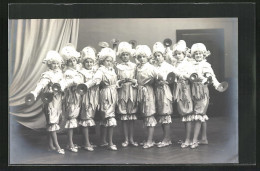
[8,19,79,129]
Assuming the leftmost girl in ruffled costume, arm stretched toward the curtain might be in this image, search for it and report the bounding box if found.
[27,50,65,154]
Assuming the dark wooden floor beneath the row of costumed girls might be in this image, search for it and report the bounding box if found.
[9,116,238,165]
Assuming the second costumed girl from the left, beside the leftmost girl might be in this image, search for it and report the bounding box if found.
[60,44,84,152]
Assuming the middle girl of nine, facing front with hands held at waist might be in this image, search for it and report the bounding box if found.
[116,42,138,147]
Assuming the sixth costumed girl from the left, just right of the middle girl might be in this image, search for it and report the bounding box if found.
[135,45,157,148]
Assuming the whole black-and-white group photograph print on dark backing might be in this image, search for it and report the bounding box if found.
[8,17,239,165]
